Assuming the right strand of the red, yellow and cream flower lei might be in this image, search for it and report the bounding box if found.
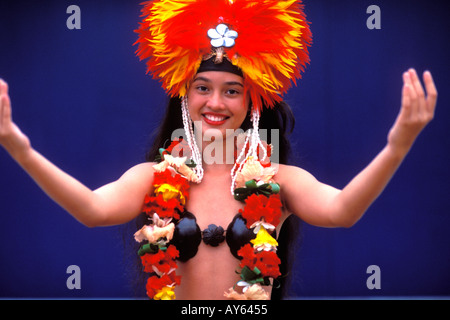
[225,148,282,300]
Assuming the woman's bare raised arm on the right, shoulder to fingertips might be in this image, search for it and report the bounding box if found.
[279,69,437,227]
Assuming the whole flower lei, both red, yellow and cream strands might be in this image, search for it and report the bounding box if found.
[134,141,282,300]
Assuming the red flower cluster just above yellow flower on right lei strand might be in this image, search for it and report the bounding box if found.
[239,194,282,228]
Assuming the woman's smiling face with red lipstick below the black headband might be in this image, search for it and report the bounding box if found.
[188,71,249,136]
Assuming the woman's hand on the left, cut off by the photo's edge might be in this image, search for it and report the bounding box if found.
[0,79,30,160]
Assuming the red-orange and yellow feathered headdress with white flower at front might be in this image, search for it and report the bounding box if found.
[135,0,311,108]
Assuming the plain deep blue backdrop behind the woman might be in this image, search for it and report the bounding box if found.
[0,0,450,298]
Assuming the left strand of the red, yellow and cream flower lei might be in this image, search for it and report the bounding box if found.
[134,141,192,300]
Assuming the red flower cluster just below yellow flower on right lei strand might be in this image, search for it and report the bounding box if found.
[238,244,281,278]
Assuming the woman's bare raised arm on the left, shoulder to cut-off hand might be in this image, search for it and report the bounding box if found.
[0,79,153,227]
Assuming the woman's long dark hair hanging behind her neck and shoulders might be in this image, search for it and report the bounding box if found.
[136,98,300,299]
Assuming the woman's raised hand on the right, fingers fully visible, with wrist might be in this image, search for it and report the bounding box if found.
[388,69,437,155]
